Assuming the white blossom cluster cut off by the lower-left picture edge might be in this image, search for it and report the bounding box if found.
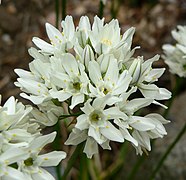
[0,97,66,180]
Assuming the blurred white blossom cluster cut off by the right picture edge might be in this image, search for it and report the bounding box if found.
[162,25,186,77]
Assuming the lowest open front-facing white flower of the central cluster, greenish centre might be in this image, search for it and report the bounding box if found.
[65,97,126,157]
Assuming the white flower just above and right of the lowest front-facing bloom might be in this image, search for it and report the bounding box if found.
[88,57,132,105]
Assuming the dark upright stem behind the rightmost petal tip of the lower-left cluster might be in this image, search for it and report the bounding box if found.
[52,121,61,180]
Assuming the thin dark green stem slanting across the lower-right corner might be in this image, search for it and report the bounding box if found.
[150,123,186,180]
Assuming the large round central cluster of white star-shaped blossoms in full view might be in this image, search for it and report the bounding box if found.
[15,16,171,159]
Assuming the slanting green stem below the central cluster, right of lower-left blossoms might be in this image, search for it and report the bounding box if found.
[61,143,84,180]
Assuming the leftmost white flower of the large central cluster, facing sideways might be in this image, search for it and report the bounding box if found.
[15,48,52,104]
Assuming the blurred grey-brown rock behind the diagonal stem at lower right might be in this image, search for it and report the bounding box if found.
[154,92,186,180]
